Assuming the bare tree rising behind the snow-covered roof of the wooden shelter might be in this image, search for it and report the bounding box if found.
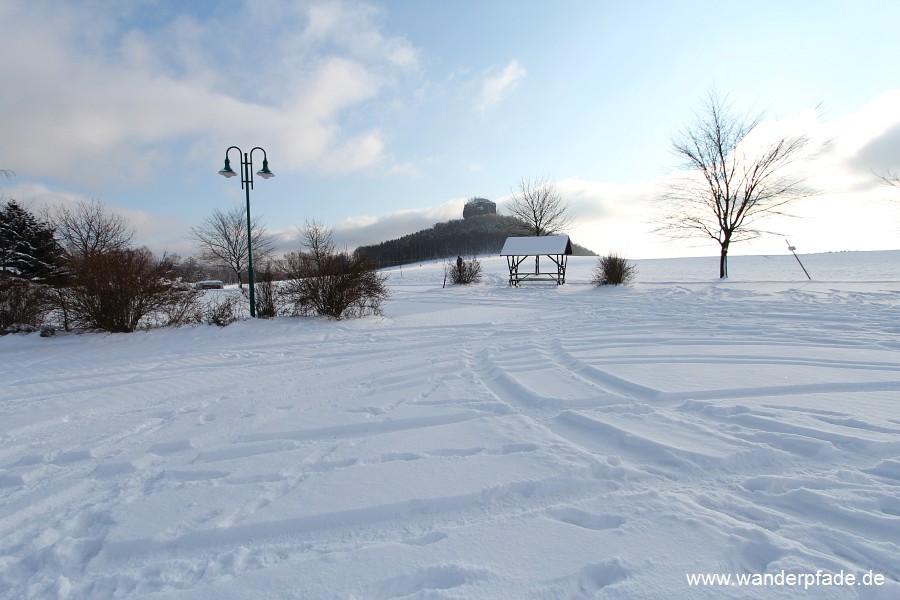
[507,177,573,235]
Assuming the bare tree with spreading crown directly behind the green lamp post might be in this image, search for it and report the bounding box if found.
[191,205,275,289]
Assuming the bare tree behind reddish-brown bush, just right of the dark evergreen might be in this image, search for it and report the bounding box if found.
[47,200,134,257]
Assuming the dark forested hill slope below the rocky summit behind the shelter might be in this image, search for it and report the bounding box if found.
[355,214,596,268]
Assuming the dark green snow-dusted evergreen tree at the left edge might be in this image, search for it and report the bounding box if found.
[0,200,62,280]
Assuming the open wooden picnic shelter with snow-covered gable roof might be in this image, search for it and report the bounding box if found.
[500,235,572,287]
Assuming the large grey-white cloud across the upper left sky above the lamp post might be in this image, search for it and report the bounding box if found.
[0,0,417,183]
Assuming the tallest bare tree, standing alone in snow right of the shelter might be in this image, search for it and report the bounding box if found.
[656,91,813,278]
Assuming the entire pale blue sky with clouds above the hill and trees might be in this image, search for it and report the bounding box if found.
[0,0,900,258]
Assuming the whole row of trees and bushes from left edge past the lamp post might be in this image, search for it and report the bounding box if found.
[0,201,389,336]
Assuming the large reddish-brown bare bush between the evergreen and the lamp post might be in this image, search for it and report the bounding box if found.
[67,248,195,333]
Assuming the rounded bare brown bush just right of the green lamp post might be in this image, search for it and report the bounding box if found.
[283,223,390,319]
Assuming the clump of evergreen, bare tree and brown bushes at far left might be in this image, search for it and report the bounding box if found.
[0,201,192,334]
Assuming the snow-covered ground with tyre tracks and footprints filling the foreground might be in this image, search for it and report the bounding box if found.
[0,252,900,600]
